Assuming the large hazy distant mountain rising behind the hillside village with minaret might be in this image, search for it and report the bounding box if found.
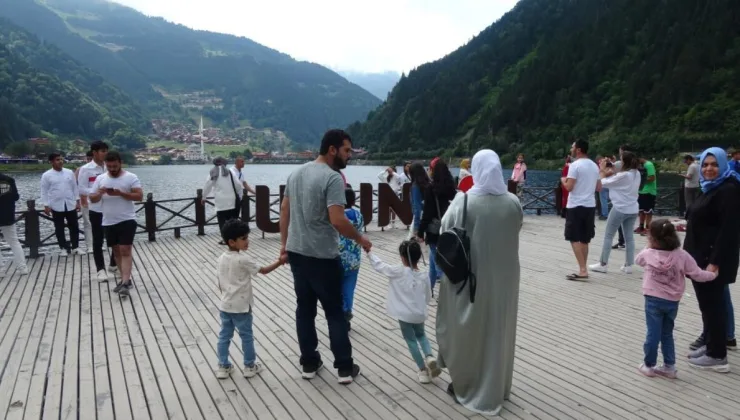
[0,0,380,145]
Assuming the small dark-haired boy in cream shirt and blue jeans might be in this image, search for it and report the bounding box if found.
[216,219,282,379]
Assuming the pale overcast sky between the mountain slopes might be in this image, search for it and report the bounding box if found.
[115,0,517,73]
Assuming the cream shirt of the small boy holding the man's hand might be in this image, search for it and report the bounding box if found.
[218,251,260,314]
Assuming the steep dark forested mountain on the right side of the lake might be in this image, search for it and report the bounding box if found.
[349,0,740,161]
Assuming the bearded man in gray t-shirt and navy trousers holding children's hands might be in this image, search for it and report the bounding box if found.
[280,130,372,385]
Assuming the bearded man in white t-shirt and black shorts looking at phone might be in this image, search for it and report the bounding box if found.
[89,151,144,296]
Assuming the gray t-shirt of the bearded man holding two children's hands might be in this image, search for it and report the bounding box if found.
[285,162,345,259]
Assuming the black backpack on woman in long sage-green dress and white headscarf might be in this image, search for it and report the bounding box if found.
[436,194,476,303]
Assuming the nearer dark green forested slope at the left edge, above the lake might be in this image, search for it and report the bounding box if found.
[0,18,148,147]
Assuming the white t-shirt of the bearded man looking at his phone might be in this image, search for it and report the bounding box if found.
[92,170,141,226]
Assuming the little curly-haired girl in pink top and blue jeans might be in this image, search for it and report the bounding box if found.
[635,220,717,379]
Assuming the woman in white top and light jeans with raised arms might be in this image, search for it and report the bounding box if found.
[589,151,640,274]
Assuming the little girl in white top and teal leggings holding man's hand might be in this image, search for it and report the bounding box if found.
[368,241,442,384]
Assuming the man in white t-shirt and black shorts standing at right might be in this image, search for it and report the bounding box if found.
[560,140,601,280]
